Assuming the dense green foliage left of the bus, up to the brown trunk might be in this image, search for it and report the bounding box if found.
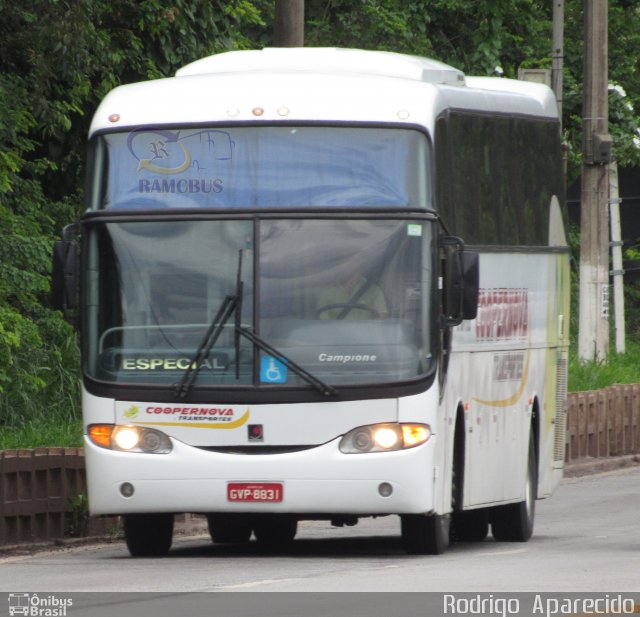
[0,0,265,434]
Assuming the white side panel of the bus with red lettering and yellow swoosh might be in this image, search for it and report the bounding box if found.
[444,252,568,507]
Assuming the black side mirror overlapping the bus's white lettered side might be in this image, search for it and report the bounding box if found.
[440,236,480,327]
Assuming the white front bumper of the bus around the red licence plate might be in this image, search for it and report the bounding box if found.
[85,436,435,518]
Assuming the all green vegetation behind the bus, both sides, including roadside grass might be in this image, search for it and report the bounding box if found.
[0,0,640,449]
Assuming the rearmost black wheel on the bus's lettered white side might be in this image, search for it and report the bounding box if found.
[491,435,538,542]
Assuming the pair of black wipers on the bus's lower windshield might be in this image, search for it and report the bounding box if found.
[175,250,337,398]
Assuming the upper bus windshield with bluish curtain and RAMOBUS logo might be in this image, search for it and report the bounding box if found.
[90,125,431,210]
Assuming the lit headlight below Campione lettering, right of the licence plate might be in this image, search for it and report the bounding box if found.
[340,424,431,454]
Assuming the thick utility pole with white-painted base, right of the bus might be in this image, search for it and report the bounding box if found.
[578,0,611,362]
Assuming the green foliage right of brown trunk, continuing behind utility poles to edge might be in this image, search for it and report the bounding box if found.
[306,0,640,178]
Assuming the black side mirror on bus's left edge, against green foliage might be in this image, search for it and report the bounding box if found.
[51,225,78,323]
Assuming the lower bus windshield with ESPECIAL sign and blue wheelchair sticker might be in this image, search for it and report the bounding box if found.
[84,218,434,388]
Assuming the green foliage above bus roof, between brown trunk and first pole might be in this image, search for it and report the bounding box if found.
[307,0,550,75]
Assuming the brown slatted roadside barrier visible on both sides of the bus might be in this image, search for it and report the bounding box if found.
[0,385,640,545]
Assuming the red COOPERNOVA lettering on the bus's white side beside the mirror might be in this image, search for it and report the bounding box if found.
[475,287,529,341]
